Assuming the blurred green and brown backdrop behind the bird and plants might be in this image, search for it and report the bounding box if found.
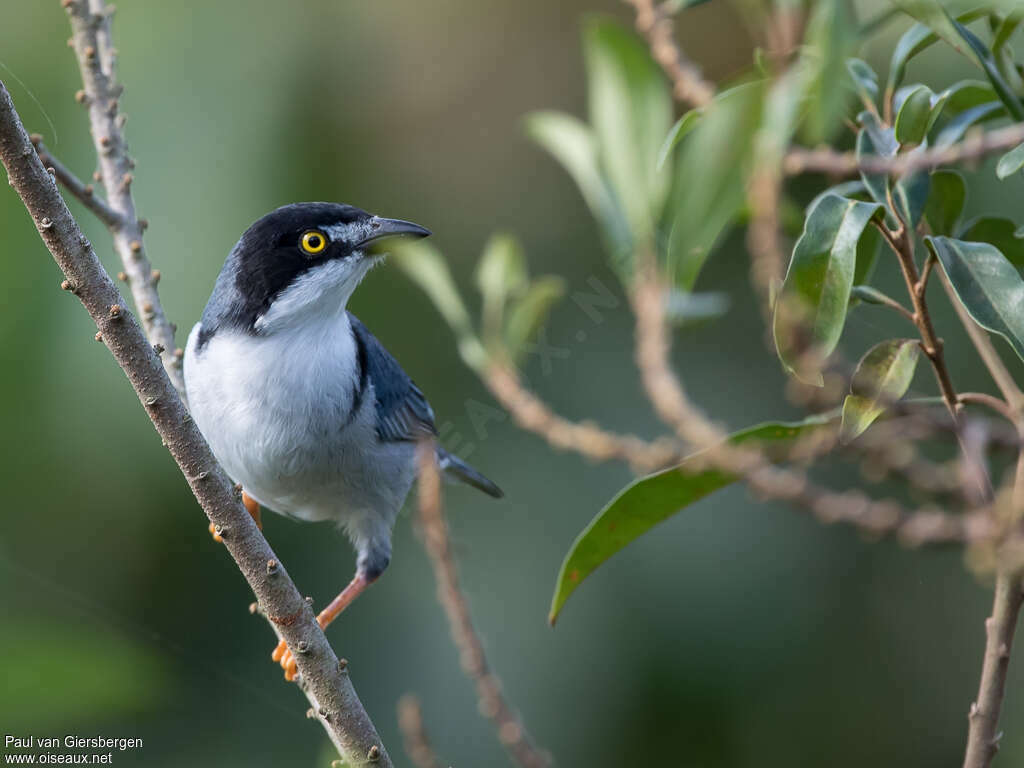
[0,0,1024,768]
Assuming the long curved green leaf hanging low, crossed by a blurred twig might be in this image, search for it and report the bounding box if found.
[548,412,837,624]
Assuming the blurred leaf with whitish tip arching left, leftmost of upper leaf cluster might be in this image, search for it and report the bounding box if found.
[526,112,633,274]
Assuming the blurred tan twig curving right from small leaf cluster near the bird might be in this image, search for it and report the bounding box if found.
[483,362,685,472]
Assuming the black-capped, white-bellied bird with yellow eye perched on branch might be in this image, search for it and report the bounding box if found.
[184,203,503,680]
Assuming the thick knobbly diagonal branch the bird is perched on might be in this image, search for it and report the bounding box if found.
[0,82,391,767]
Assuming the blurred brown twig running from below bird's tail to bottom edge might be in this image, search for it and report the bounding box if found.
[418,440,551,768]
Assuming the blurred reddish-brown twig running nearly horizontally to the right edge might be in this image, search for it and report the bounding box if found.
[782,123,1024,176]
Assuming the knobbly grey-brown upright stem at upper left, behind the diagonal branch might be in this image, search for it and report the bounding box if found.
[62,0,184,397]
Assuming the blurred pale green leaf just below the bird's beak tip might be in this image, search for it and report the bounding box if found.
[389,241,487,372]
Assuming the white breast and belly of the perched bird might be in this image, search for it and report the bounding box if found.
[184,313,415,538]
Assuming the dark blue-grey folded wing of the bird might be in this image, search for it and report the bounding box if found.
[348,313,437,442]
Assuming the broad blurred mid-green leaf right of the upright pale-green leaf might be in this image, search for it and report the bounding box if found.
[668,82,764,291]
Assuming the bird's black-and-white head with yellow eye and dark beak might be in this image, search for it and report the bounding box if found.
[203,203,430,334]
